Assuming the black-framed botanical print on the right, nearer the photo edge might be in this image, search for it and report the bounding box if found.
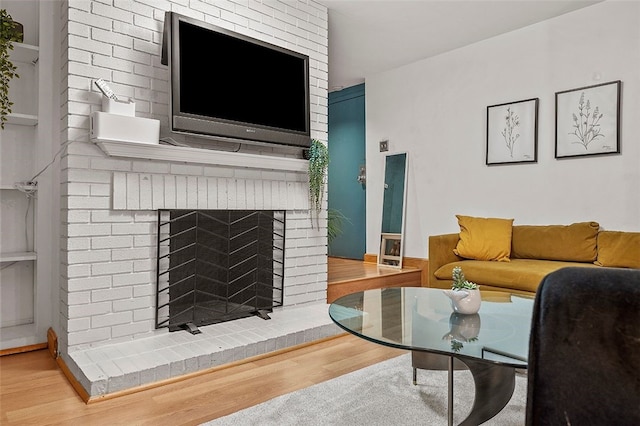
[555,80,621,158]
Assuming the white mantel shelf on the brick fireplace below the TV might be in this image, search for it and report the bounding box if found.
[95,140,309,173]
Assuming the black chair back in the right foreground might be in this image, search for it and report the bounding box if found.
[526,267,640,426]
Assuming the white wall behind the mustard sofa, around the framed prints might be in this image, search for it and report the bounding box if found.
[366,1,640,258]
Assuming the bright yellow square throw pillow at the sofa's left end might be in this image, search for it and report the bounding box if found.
[453,215,513,262]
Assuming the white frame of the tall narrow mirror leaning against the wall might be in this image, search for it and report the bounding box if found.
[378,152,409,268]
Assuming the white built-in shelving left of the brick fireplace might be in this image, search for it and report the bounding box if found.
[0,0,46,350]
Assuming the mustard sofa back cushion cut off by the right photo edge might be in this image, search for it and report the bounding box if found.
[594,231,640,269]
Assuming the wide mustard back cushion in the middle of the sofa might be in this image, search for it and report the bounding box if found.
[511,222,600,262]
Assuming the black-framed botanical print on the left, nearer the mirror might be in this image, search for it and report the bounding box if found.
[486,98,538,166]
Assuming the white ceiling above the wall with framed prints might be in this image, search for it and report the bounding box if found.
[318,0,602,91]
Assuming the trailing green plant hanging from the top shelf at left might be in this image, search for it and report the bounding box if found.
[0,9,22,129]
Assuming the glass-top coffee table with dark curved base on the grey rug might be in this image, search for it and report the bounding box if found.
[329,287,534,425]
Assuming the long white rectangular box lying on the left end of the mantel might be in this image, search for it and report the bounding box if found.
[90,111,160,145]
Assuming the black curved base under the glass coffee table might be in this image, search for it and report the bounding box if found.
[456,359,516,426]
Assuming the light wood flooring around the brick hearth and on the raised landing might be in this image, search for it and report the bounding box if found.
[0,258,409,426]
